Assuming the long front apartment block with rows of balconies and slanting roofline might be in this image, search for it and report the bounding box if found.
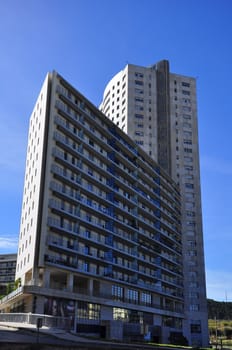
[0,72,190,343]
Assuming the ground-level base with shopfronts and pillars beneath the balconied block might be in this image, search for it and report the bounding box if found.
[0,271,198,343]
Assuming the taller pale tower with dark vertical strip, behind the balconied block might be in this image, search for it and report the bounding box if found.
[100,60,208,345]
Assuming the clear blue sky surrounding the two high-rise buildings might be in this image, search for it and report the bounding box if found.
[0,0,232,301]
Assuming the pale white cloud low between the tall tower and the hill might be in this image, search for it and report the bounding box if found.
[206,269,232,301]
